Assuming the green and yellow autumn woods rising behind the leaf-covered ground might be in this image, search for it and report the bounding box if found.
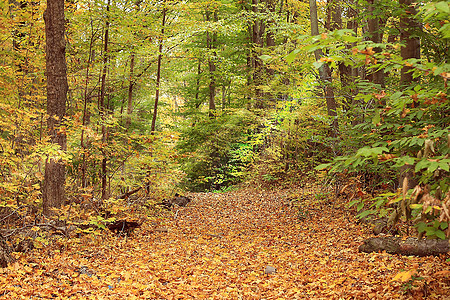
[0,0,450,282]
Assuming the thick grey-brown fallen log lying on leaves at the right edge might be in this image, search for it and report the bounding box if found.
[359,236,450,256]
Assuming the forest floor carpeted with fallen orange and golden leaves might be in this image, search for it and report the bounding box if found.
[0,188,450,299]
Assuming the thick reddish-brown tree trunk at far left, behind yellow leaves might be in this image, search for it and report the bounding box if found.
[42,0,68,214]
